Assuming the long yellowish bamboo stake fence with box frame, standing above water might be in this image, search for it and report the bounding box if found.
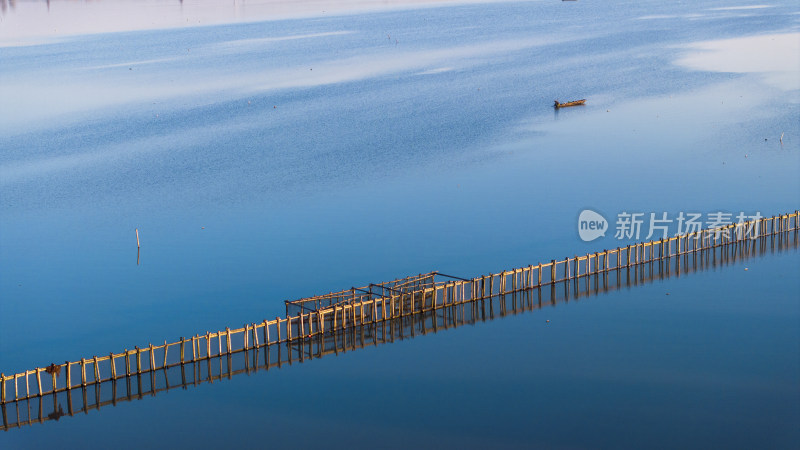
[0,212,798,410]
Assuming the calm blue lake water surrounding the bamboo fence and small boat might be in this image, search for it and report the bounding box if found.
[0,0,800,448]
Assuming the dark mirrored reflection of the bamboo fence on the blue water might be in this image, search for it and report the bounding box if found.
[6,223,800,430]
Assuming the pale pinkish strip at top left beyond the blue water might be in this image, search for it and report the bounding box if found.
[0,0,515,47]
